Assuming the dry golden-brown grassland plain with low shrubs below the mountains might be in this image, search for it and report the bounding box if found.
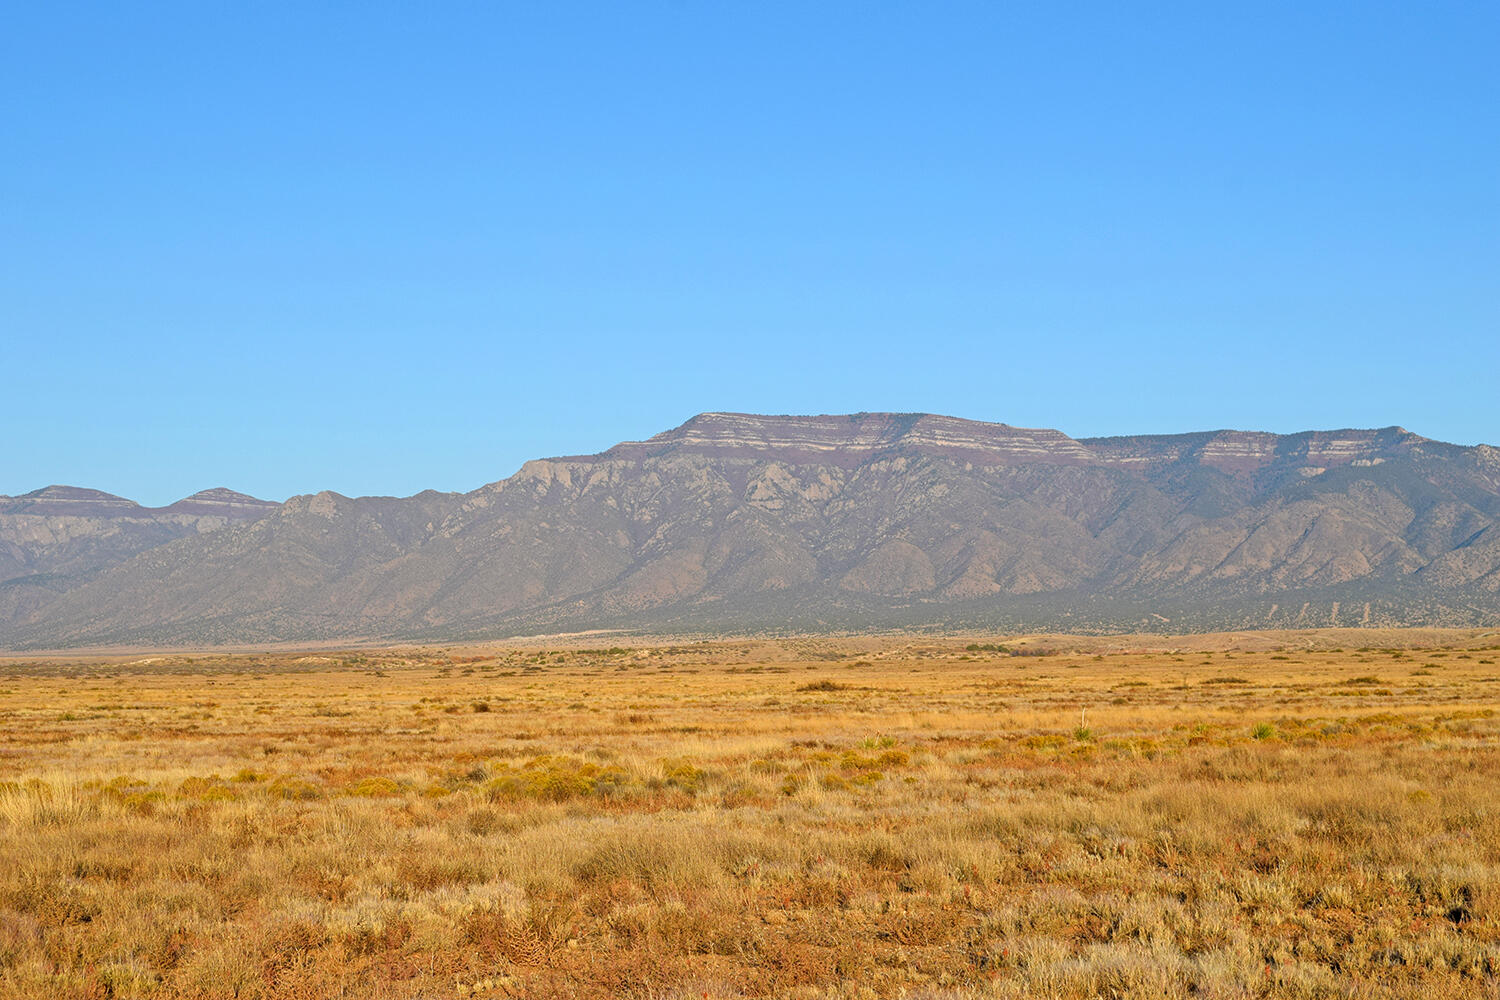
[0,633,1500,1000]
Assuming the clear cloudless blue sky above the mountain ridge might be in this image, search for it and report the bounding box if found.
[0,0,1500,504]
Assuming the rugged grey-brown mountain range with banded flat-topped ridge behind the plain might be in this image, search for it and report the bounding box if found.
[0,414,1500,649]
